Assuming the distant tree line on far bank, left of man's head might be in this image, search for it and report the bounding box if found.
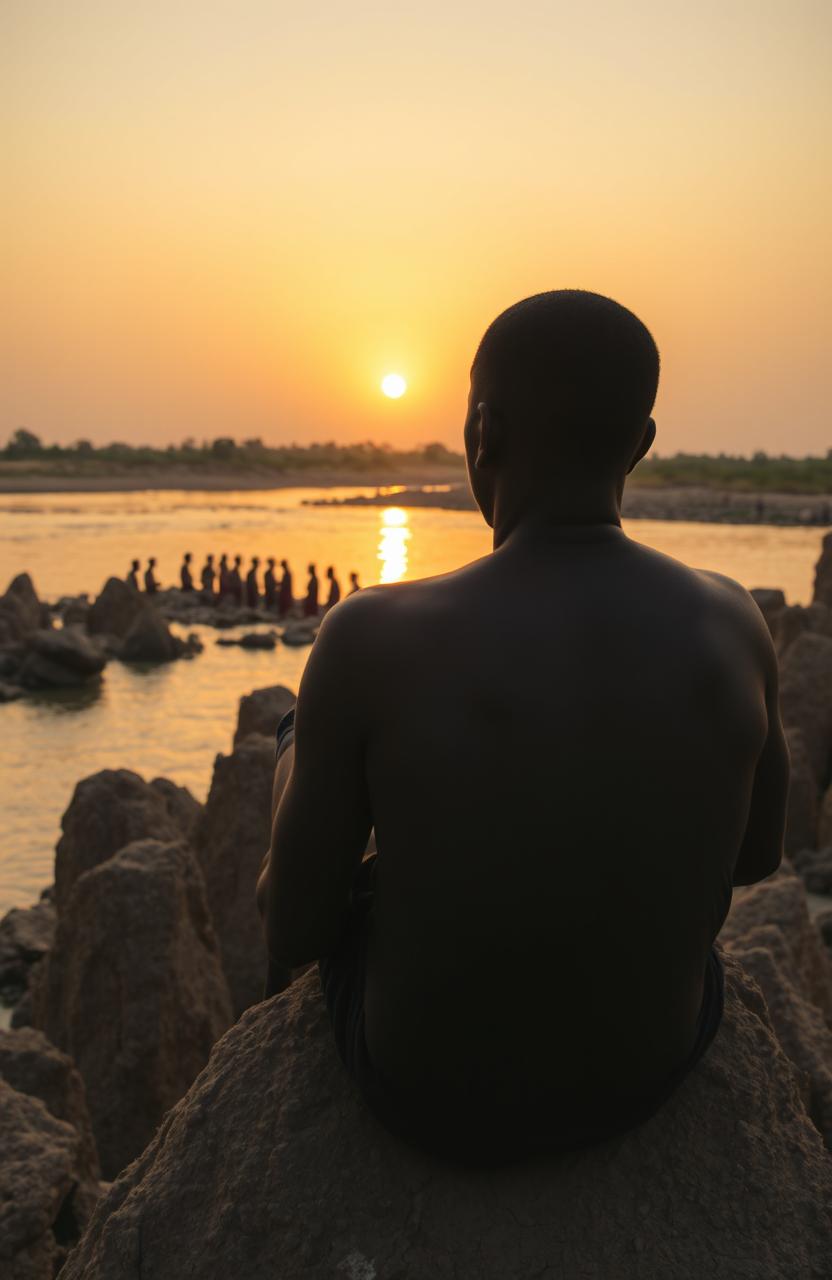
[0,428,463,472]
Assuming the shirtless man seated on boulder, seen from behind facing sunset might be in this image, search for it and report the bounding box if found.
[259,291,788,1161]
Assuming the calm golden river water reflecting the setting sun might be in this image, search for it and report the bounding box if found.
[0,489,826,915]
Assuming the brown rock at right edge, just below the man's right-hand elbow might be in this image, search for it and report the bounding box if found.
[719,874,832,1149]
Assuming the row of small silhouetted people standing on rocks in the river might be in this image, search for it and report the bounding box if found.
[127,552,360,618]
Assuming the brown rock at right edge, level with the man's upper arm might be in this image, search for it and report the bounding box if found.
[780,631,832,788]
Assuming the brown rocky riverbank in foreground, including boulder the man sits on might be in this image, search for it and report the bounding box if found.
[0,535,832,1280]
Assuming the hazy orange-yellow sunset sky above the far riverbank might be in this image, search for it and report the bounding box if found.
[0,0,832,453]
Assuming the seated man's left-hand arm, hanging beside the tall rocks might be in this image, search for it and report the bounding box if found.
[259,605,372,968]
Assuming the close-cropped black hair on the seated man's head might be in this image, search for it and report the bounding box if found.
[471,289,659,471]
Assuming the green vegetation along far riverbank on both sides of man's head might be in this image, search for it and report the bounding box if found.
[0,428,832,494]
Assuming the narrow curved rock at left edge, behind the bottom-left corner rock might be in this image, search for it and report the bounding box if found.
[0,1028,100,1182]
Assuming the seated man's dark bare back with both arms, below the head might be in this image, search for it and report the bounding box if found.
[258,293,787,1162]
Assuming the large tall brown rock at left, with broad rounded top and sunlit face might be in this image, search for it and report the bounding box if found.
[35,840,232,1178]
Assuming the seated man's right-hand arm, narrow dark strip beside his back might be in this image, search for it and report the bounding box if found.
[733,593,788,884]
